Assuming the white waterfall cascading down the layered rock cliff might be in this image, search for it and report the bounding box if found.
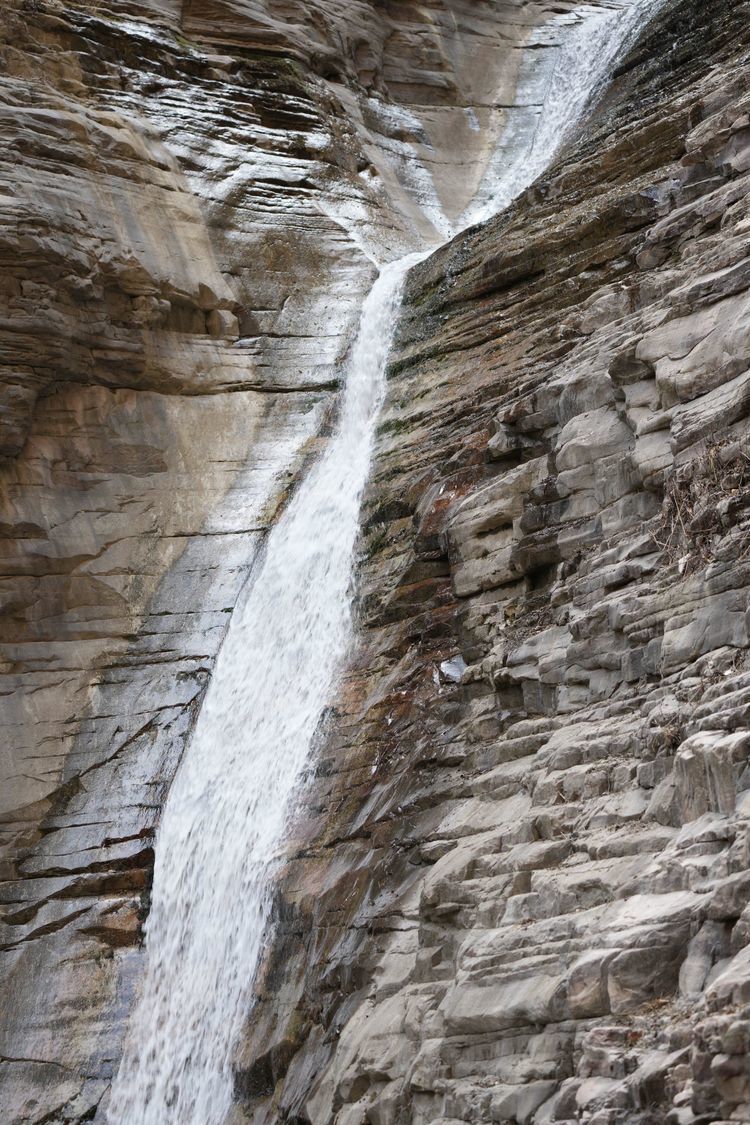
[107,0,660,1125]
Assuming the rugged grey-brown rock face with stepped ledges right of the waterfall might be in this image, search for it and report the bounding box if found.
[246,0,750,1125]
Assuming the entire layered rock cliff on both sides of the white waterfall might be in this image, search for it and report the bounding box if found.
[0,0,750,1125]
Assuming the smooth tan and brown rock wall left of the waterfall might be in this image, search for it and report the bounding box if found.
[0,0,647,1125]
